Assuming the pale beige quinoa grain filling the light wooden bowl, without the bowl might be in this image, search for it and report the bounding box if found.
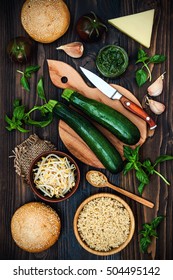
[77,197,130,252]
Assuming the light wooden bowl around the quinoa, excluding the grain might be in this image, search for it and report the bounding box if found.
[73,193,135,256]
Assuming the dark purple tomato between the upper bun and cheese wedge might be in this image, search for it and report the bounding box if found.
[76,12,107,42]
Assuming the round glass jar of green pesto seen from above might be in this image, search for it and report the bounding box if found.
[96,45,129,78]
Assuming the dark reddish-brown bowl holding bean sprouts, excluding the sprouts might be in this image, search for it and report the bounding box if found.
[29,151,80,202]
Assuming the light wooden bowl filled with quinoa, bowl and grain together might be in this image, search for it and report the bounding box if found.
[74,193,135,255]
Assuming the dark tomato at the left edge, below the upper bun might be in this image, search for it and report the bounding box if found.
[7,36,33,63]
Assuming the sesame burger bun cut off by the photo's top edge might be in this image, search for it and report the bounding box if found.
[21,0,70,43]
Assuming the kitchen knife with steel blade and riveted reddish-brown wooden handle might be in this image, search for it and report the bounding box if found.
[80,67,157,129]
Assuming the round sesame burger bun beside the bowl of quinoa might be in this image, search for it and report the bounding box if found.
[11,202,61,253]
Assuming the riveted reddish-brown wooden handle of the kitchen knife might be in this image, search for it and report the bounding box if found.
[120,96,157,129]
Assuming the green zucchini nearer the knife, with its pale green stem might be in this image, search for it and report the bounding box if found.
[62,89,140,145]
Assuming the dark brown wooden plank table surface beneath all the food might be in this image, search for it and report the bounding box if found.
[0,0,173,260]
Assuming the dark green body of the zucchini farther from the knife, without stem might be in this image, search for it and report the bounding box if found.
[53,102,123,174]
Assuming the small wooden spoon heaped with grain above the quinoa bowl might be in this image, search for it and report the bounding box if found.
[86,170,154,208]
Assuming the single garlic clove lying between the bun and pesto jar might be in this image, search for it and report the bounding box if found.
[56,42,84,58]
